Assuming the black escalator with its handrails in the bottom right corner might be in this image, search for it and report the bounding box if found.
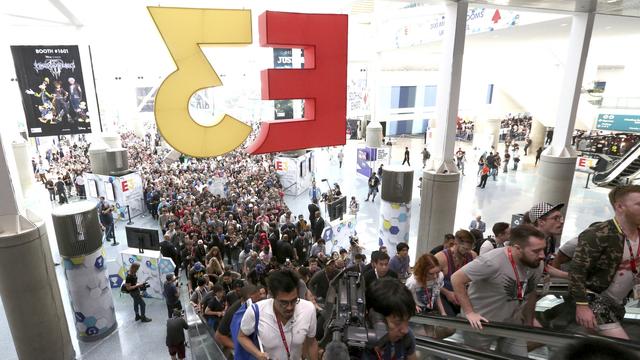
[411,315,640,359]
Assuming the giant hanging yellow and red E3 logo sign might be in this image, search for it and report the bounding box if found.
[149,7,347,157]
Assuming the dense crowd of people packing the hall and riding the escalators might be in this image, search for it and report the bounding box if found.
[34,133,640,359]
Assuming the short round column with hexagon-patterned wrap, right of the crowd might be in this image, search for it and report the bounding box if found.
[378,166,413,256]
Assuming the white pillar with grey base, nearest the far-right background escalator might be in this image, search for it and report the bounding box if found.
[534,11,595,212]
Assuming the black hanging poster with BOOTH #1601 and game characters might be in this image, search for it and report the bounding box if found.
[11,45,91,137]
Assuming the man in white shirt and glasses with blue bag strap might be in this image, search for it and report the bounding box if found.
[238,270,318,360]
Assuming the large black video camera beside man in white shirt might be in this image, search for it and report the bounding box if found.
[320,270,387,359]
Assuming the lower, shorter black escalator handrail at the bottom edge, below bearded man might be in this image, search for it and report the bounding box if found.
[415,336,527,360]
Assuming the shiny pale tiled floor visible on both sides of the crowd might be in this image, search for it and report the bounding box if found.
[0,138,612,360]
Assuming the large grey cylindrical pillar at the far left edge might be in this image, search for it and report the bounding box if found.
[0,133,75,360]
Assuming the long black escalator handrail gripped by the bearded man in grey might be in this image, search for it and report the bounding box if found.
[411,315,640,354]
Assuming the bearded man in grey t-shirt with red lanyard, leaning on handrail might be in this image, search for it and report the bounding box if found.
[451,225,546,357]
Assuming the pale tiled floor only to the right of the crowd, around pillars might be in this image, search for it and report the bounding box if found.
[286,138,613,260]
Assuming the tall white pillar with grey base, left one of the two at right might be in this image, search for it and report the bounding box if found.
[416,1,469,254]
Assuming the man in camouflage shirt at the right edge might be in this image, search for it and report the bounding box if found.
[569,185,640,339]
